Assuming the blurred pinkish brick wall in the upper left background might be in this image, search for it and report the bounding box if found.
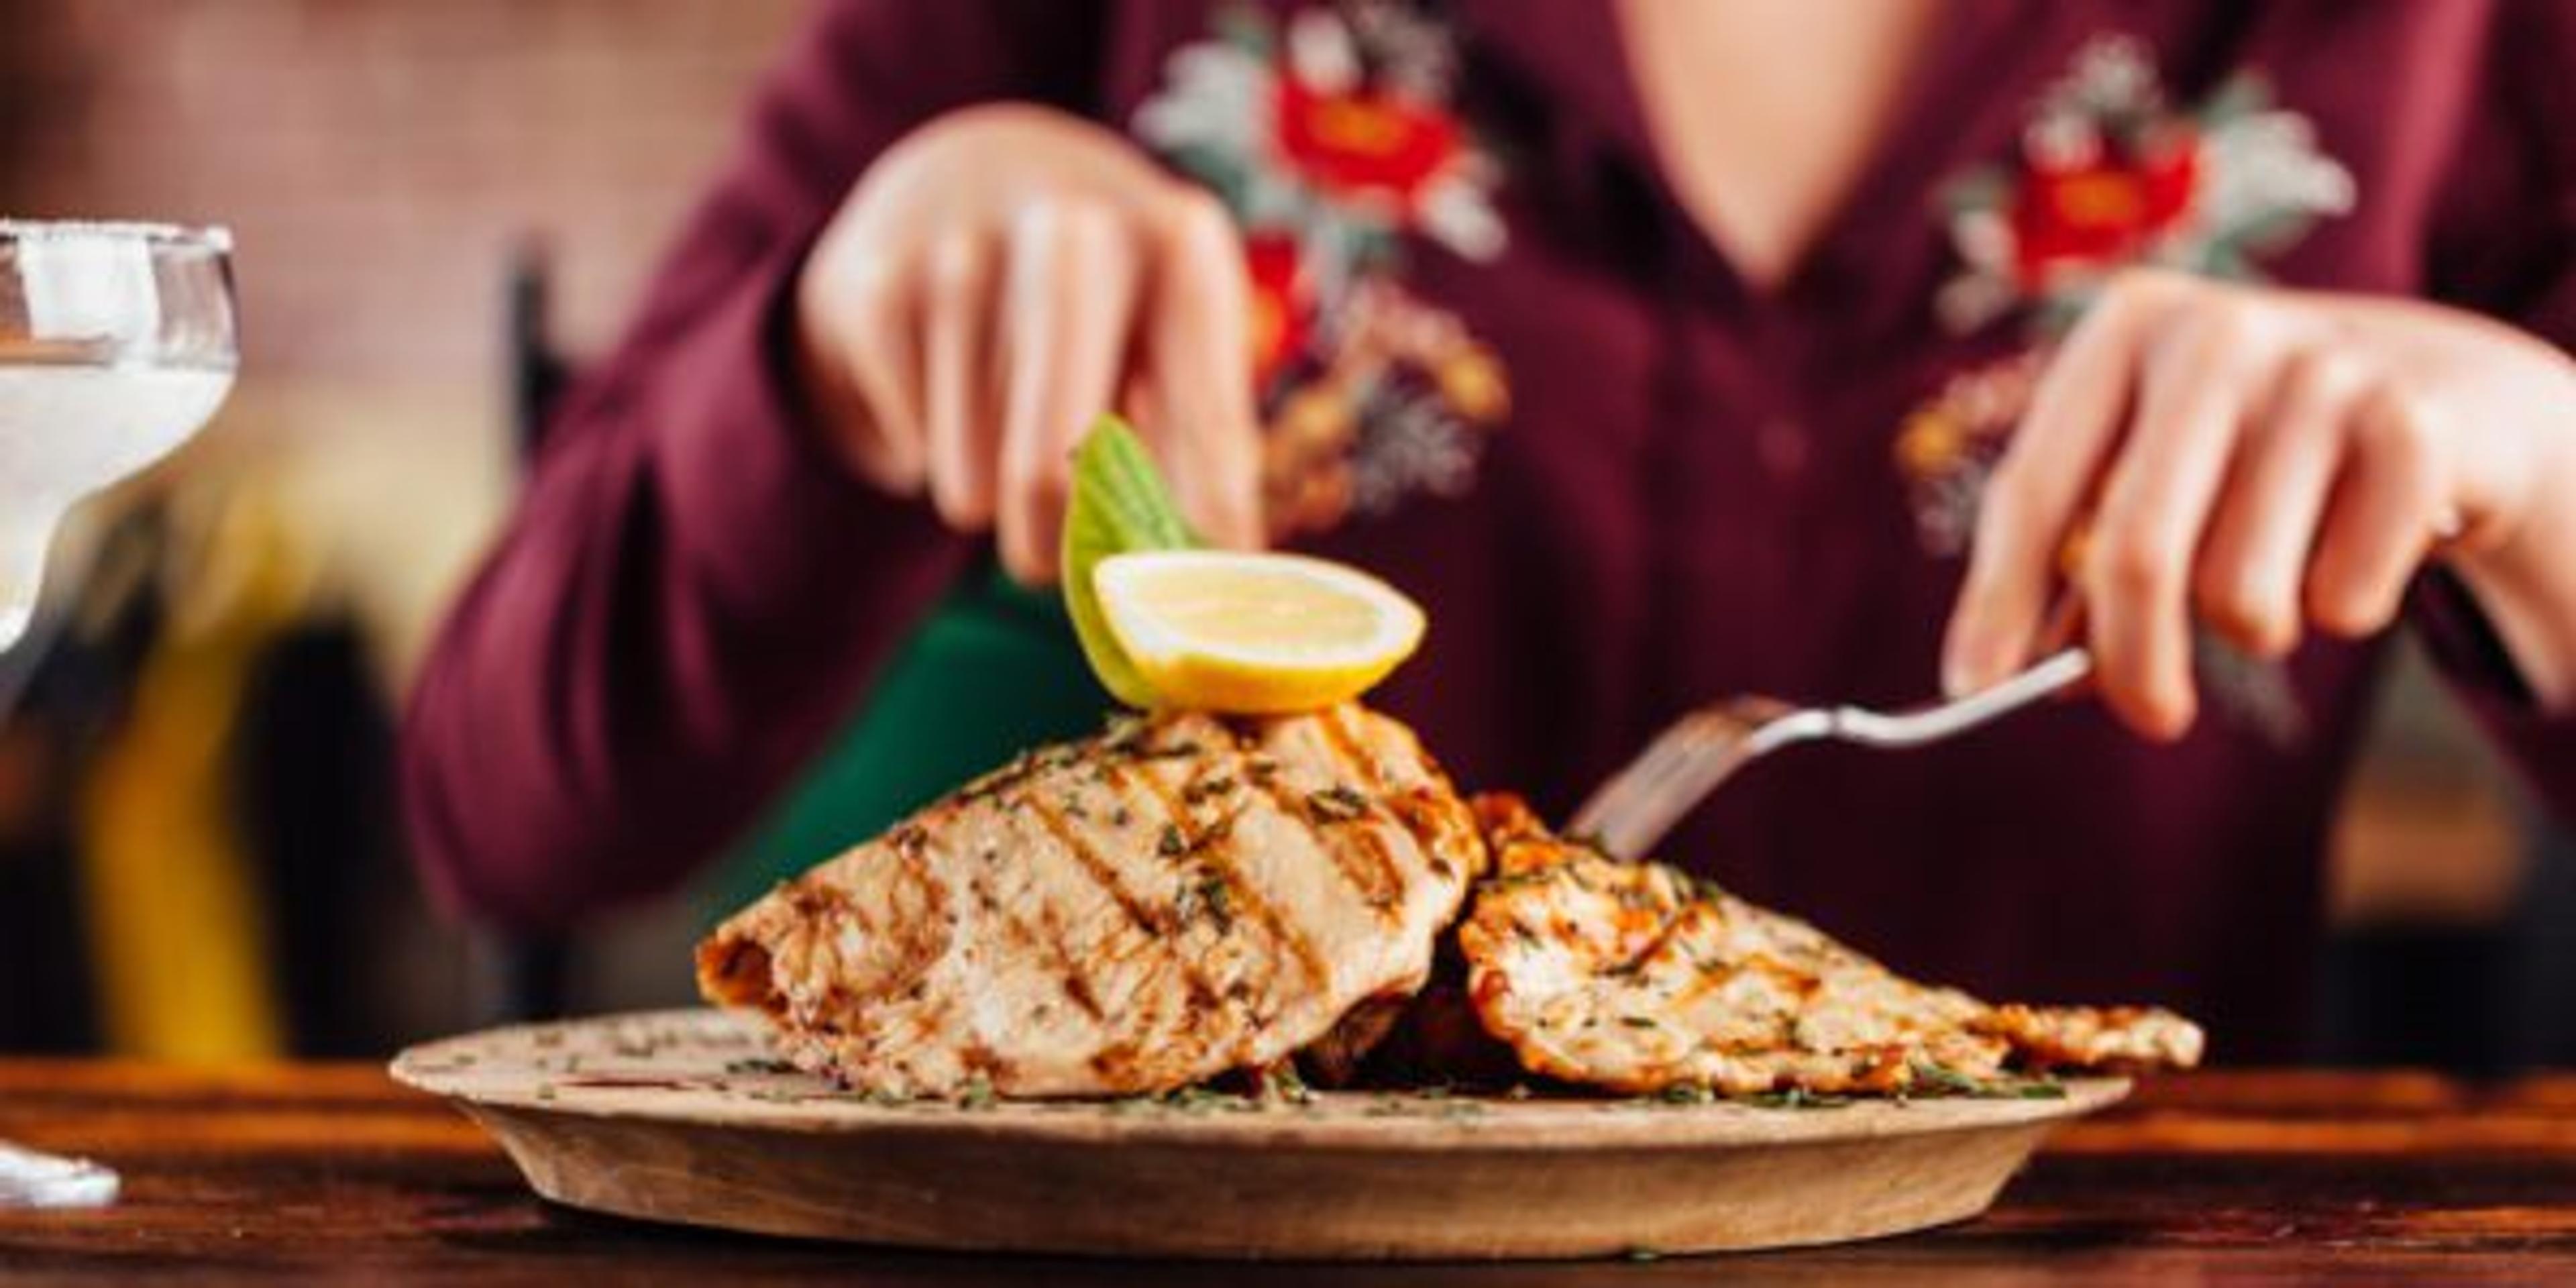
[0,0,804,399]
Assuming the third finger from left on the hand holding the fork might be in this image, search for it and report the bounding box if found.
[2192,350,2362,657]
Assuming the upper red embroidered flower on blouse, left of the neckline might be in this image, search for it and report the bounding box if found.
[1278,70,1460,217]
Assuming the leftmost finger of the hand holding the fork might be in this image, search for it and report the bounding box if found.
[1942,276,2169,693]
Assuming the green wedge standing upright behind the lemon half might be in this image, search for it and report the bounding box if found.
[1059,415,1200,708]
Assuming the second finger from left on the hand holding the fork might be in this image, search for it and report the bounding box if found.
[2082,294,2267,739]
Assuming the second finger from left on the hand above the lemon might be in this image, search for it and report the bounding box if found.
[922,229,1002,531]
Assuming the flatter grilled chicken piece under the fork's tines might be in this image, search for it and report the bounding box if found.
[1458,796,2200,1095]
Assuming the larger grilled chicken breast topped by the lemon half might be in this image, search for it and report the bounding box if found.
[698,706,1484,1097]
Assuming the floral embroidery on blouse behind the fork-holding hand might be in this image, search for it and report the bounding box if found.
[1896,36,2355,747]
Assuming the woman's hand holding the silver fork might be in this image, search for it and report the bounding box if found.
[1942,270,2576,739]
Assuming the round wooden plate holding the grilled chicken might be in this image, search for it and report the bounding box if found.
[394,1010,2128,1260]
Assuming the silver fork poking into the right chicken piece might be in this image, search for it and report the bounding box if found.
[1566,649,2092,858]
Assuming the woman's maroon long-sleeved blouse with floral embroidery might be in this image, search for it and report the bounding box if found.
[405,0,2576,1059]
